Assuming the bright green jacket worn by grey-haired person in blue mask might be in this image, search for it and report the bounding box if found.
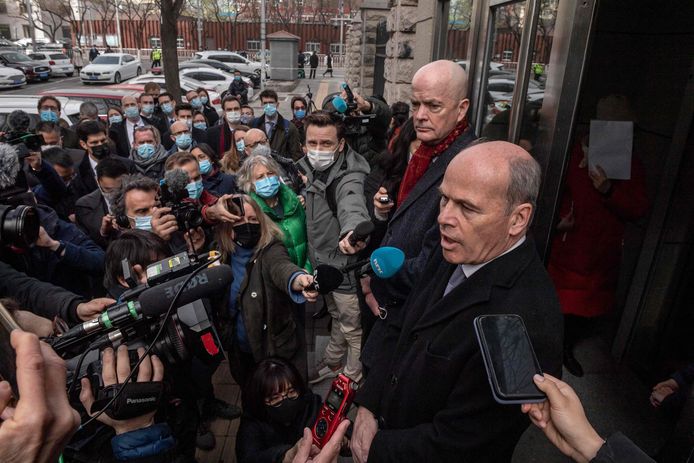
[251,184,313,273]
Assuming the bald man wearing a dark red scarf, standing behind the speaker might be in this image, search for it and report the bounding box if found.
[362,60,475,368]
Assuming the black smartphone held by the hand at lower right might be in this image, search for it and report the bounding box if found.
[474,314,547,404]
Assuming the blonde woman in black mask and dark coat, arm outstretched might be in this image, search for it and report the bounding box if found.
[216,195,318,384]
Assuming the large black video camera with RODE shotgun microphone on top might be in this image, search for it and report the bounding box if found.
[45,256,232,416]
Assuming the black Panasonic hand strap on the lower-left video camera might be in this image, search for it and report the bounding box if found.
[91,381,164,420]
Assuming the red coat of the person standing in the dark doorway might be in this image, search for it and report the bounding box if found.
[548,142,648,317]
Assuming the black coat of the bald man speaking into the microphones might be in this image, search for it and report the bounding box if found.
[356,240,563,463]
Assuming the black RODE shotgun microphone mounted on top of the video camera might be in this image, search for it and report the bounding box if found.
[60,265,233,339]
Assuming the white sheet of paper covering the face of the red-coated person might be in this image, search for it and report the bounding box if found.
[588,120,634,180]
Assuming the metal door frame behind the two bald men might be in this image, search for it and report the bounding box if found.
[469,0,598,260]
